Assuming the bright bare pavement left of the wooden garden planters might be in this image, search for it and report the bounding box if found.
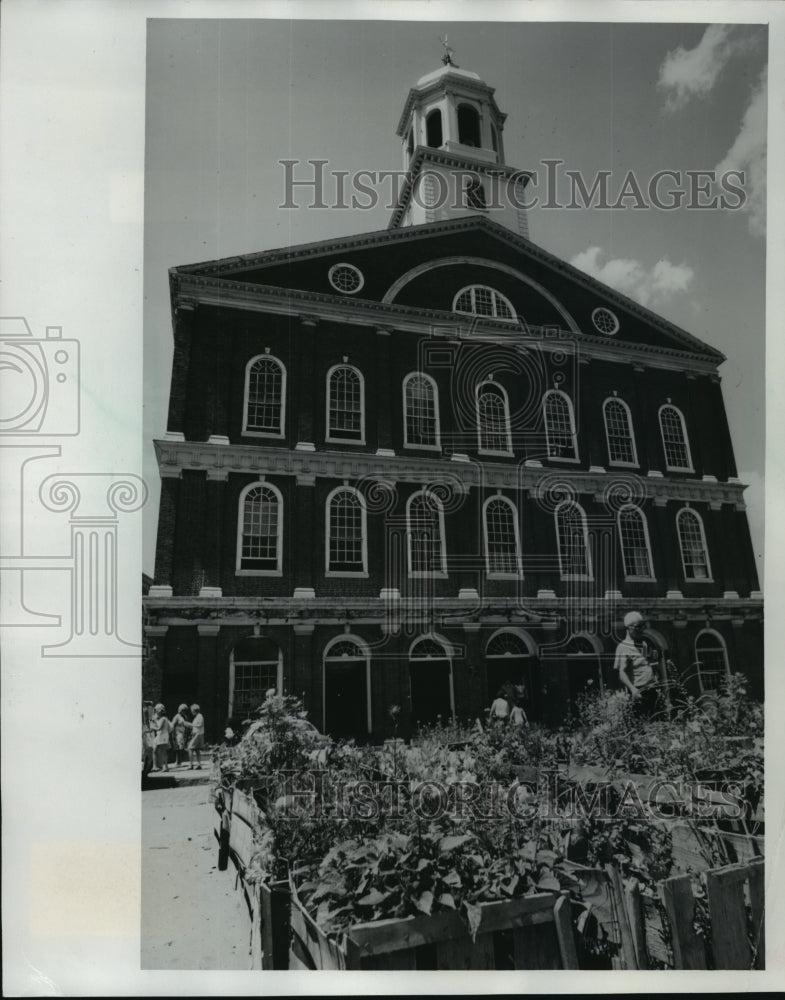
[141,765,251,970]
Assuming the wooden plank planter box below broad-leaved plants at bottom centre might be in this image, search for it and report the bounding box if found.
[289,883,578,971]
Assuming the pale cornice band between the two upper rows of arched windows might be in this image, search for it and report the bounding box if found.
[154,440,746,510]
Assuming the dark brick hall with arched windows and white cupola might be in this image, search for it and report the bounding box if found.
[144,61,763,740]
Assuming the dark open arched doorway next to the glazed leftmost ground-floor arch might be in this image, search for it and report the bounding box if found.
[322,635,371,739]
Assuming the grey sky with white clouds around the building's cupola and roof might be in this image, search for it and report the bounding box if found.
[144,19,767,575]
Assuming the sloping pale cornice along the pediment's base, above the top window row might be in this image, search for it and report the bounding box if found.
[173,274,717,375]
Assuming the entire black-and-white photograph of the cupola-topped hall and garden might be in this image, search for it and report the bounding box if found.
[142,11,767,970]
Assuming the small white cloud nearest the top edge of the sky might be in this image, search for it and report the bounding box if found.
[657,24,746,111]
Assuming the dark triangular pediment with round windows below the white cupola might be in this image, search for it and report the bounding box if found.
[171,215,724,365]
